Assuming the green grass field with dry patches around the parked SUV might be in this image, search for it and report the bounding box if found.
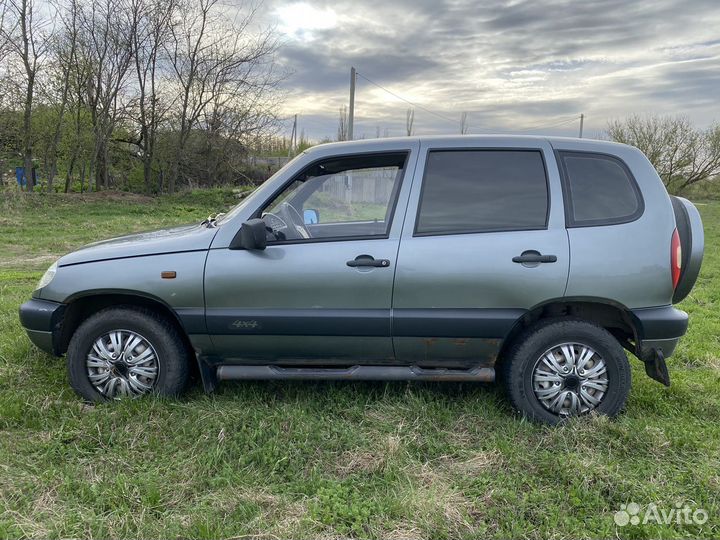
[0,192,720,539]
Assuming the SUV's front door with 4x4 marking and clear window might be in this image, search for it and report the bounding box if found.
[205,149,418,365]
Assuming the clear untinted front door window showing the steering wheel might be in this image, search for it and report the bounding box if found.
[260,153,407,242]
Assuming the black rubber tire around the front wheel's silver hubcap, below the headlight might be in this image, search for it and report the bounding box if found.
[67,306,189,403]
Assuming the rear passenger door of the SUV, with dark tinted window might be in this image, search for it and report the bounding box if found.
[393,138,569,367]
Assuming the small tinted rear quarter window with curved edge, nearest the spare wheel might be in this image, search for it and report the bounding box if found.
[559,152,643,227]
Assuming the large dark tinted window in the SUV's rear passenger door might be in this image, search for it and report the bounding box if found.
[415,150,548,235]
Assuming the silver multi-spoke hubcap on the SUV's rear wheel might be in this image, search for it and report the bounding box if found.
[533,343,608,416]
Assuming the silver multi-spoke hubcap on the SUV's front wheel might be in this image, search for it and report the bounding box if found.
[86,330,160,398]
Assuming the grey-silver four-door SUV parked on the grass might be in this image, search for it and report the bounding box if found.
[20,136,703,423]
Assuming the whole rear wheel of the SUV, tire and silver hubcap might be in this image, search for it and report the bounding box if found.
[502,319,630,424]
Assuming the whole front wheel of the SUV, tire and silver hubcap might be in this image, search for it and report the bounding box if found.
[67,307,188,402]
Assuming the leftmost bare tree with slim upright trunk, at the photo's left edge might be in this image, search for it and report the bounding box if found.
[0,0,49,191]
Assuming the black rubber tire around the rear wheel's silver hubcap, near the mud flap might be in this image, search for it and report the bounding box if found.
[500,318,631,424]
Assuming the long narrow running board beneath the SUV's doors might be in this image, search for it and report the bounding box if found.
[217,365,495,382]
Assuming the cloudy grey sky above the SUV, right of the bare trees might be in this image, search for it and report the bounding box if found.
[263,0,720,139]
